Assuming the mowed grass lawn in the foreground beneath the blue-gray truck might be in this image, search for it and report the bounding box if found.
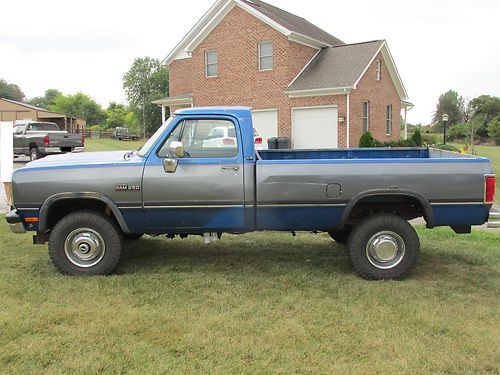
[0,222,500,374]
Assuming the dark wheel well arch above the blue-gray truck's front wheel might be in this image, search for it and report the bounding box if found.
[38,193,130,233]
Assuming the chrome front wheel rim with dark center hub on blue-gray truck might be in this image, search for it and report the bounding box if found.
[64,228,106,268]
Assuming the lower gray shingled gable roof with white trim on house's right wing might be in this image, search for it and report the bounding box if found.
[288,40,408,100]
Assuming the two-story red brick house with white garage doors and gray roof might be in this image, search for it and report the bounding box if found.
[155,0,411,148]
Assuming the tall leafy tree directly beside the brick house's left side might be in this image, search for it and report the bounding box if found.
[123,57,168,136]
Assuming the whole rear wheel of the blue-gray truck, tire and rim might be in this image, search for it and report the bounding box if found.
[347,214,420,280]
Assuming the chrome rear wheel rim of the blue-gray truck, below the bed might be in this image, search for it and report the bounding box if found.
[366,231,405,270]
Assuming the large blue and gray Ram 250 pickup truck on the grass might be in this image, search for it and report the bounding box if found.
[6,108,498,279]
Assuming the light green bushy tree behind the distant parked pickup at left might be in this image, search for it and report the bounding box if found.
[48,92,105,125]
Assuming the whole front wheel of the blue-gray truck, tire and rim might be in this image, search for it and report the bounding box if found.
[49,211,123,276]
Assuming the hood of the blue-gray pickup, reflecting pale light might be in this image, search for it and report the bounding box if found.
[22,151,145,169]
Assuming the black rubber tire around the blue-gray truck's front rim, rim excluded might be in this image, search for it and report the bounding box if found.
[49,211,123,275]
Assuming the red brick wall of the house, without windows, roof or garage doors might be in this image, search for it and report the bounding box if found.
[169,7,400,147]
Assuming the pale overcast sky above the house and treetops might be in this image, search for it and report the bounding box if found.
[0,0,500,124]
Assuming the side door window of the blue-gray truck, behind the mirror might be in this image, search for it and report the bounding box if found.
[158,119,238,158]
